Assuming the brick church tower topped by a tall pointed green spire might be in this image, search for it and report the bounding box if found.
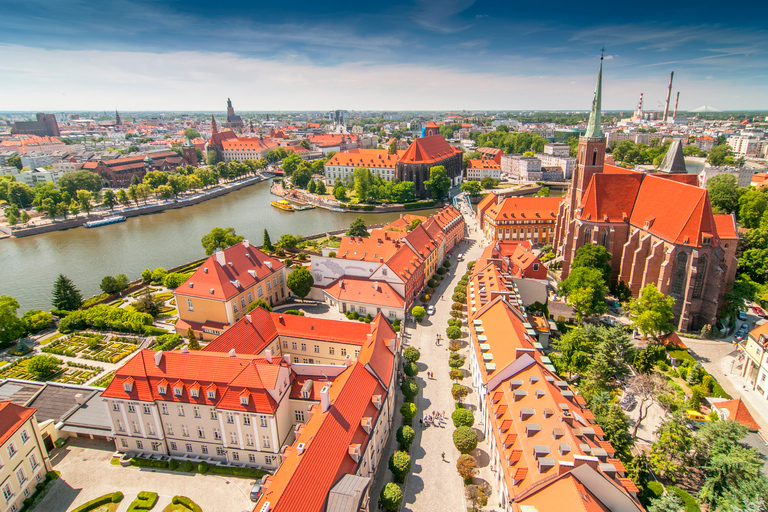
[568,54,605,218]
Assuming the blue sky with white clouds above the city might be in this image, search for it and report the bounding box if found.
[0,0,768,112]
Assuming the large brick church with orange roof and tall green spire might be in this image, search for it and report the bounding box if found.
[554,59,738,330]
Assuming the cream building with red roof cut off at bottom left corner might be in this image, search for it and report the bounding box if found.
[0,401,51,512]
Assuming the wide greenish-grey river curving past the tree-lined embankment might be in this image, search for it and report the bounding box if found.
[0,180,434,312]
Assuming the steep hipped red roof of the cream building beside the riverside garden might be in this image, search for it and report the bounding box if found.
[174,241,285,300]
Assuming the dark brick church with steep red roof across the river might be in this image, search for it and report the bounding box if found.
[395,134,462,199]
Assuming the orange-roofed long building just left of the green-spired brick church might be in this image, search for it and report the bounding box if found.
[480,192,562,244]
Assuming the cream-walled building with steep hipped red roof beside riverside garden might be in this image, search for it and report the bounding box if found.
[174,240,290,340]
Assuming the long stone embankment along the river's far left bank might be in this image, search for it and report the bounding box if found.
[3,173,274,238]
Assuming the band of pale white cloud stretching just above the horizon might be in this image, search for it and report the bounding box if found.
[0,45,768,111]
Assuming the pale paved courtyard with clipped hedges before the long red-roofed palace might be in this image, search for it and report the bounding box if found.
[35,438,254,512]
